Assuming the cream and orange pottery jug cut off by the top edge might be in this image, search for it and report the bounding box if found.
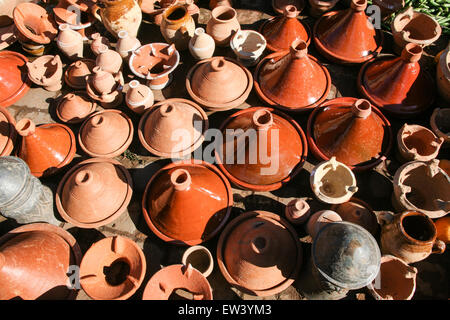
[91,0,142,38]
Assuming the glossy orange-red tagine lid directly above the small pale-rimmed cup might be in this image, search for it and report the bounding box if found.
[142,160,233,245]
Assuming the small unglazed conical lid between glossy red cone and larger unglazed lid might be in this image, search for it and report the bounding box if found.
[78,109,134,158]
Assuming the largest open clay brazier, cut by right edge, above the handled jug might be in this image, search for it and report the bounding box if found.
[392,160,450,219]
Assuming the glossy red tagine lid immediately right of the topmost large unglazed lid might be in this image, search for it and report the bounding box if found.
[254,40,331,111]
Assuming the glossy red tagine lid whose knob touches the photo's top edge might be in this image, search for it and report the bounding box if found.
[314,0,383,64]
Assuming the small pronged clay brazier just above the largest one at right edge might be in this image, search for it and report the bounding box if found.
[397,123,444,162]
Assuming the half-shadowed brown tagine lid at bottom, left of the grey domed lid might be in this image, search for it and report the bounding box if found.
[217,211,303,296]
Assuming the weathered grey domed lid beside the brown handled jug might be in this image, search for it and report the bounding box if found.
[311,222,381,290]
